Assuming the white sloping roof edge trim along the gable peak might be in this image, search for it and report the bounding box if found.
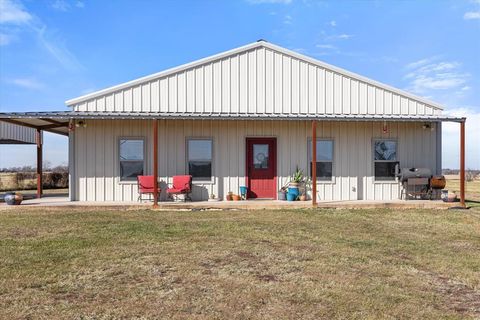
[65,40,443,110]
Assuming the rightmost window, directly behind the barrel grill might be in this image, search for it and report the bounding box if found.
[373,140,398,181]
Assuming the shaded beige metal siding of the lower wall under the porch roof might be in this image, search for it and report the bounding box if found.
[73,120,437,201]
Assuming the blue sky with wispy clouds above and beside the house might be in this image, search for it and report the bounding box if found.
[0,0,480,169]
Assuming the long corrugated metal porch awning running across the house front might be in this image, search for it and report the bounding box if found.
[0,111,466,124]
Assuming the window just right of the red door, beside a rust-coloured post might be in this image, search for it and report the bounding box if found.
[307,139,333,181]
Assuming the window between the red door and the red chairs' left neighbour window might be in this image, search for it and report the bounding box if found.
[187,139,212,181]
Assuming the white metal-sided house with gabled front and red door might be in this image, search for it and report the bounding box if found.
[0,41,465,202]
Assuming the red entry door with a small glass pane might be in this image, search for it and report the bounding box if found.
[246,138,277,199]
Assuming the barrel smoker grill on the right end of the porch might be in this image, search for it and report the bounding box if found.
[397,168,445,199]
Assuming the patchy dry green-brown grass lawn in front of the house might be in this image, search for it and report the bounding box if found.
[0,208,480,319]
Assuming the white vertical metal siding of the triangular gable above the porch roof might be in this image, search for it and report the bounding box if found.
[73,47,441,115]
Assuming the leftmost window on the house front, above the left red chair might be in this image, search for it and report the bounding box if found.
[119,138,145,181]
